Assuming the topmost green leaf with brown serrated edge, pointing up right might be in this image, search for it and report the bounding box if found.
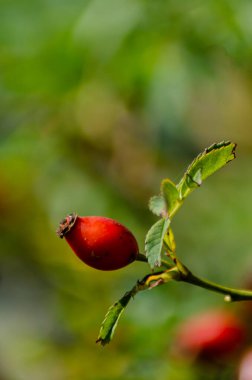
[177,141,236,200]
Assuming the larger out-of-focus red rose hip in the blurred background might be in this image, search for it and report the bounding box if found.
[174,310,245,361]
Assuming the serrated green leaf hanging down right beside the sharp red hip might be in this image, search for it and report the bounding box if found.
[145,218,171,269]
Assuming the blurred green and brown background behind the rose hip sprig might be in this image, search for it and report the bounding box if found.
[0,0,252,380]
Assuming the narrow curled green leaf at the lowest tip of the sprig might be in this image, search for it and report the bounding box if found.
[96,292,132,346]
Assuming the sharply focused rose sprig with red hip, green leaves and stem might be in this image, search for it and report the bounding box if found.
[57,141,252,346]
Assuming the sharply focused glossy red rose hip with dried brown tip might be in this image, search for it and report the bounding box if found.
[57,214,139,271]
